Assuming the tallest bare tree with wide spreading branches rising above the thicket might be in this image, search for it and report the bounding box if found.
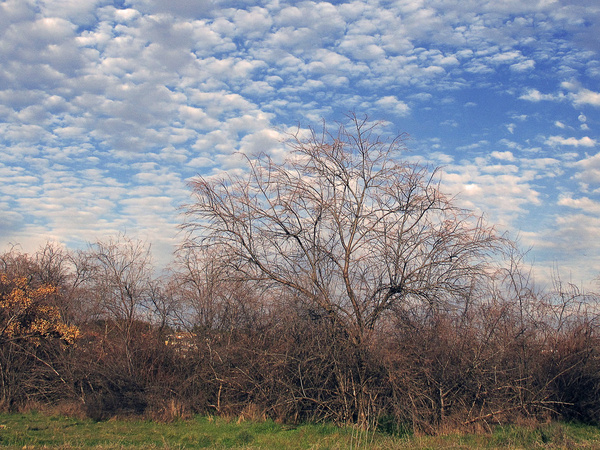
[184,115,502,420]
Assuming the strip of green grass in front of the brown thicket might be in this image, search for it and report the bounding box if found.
[0,412,600,449]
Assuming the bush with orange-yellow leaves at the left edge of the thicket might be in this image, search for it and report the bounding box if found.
[0,273,79,344]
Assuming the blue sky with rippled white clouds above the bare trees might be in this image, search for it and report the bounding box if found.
[0,0,600,288]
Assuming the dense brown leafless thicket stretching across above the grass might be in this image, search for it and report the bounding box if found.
[0,241,600,432]
